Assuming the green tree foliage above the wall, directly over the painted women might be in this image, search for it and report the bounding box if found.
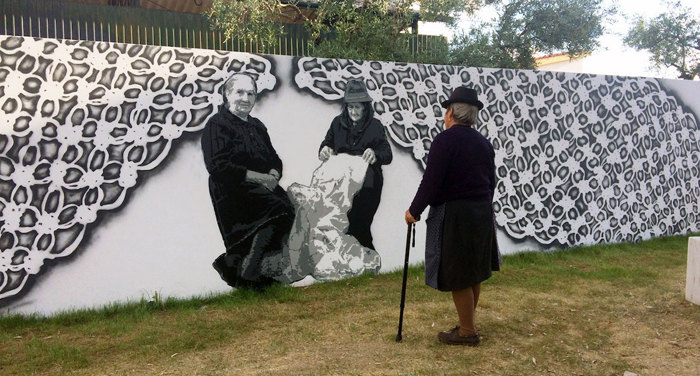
[207,0,495,63]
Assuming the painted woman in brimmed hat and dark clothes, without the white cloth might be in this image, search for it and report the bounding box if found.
[318,80,393,249]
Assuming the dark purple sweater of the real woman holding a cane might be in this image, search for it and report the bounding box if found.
[408,125,496,218]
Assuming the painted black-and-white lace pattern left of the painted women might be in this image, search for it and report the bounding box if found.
[0,37,277,299]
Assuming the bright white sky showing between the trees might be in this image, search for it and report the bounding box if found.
[419,0,700,78]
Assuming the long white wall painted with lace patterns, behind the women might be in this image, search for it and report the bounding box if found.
[0,37,700,313]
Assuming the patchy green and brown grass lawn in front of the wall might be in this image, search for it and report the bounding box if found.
[0,236,700,376]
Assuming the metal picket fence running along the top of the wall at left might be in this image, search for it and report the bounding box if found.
[0,0,445,56]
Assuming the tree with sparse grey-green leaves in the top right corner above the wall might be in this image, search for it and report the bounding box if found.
[624,2,700,80]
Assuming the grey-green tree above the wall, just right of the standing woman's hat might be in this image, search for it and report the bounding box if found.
[451,0,616,69]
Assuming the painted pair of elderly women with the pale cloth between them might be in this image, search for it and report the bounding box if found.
[202,72,392,289]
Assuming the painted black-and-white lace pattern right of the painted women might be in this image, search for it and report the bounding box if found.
[295,58,700,246]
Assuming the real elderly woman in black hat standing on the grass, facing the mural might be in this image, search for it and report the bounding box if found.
[405,87,499,346]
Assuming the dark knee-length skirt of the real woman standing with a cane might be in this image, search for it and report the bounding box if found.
[425,200,500,291]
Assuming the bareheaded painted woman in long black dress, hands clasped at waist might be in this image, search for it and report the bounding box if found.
[201,73,294,289]
